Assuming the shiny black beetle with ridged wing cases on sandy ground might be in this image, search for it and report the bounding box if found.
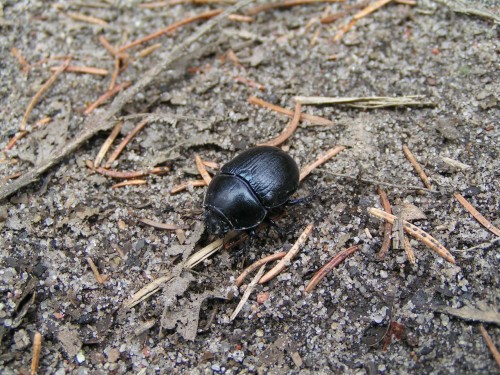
[203,146,299,235]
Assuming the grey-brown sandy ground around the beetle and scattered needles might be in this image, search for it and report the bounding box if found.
[0,1,500,374]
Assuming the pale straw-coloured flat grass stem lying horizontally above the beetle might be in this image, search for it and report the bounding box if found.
[294,95,434,109]
